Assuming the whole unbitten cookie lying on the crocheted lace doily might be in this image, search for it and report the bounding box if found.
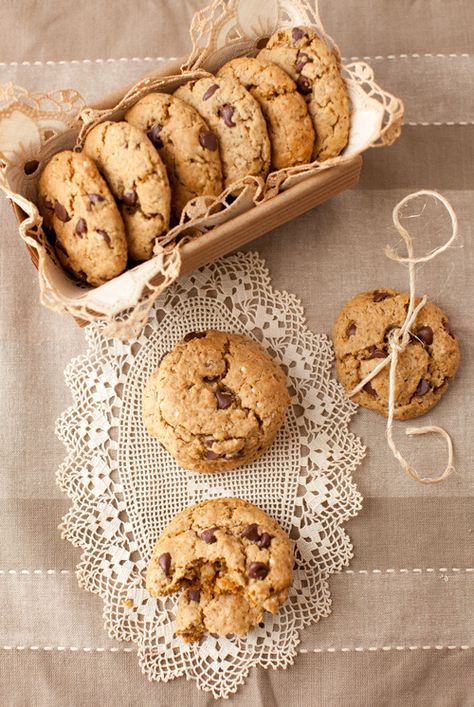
[143,331,289,473]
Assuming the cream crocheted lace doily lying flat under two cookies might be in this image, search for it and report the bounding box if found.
[57,253,364,697]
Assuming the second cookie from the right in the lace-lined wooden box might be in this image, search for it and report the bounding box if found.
[217,57,315,170]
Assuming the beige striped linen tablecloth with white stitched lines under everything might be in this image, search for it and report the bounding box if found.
[0,0,474,707]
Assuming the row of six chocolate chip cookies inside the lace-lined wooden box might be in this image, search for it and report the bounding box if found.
[39,27,350,286]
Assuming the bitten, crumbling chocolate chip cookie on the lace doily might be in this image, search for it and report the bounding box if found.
[146,498,293,642]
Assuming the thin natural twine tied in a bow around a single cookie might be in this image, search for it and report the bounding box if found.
[349,189,458,484]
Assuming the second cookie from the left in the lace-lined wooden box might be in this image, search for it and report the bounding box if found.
[84,121,171,260]
